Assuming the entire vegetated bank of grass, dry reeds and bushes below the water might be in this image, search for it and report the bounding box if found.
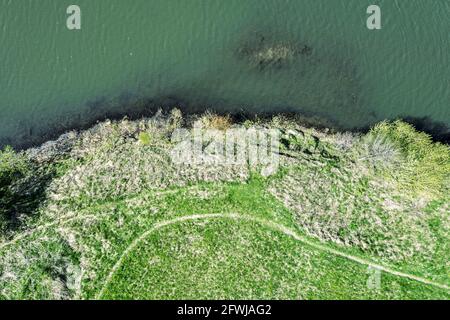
[0,109,450,299]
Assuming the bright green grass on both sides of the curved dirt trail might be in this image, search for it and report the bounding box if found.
[2,179,448,299]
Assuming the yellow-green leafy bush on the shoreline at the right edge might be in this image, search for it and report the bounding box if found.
[369,121,450,197]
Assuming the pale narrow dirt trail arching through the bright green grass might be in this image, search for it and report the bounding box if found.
[95,213,450,299]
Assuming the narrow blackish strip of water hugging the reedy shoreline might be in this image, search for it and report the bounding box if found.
[5,97,450,150]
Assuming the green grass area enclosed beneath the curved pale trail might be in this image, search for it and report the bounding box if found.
[101,219,448,299]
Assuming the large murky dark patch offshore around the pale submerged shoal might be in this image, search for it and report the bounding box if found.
[232,30,370,129]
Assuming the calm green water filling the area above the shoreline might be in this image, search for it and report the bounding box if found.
[0,0,450,145]
